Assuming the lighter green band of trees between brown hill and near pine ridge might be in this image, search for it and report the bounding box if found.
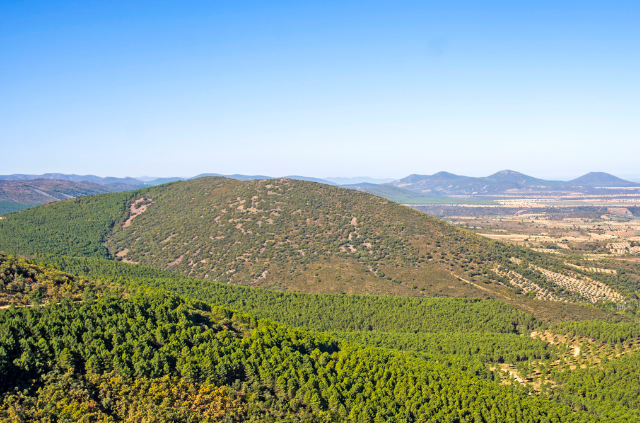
[36,256,539,333]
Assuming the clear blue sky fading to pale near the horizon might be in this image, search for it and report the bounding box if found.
[0,0,640,179]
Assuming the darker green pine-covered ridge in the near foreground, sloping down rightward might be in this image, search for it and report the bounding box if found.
[0,292,594,422]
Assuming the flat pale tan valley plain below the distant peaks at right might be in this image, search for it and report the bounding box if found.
[413,194,640,260]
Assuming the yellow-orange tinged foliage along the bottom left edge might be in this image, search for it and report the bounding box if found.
[0,372,246,423]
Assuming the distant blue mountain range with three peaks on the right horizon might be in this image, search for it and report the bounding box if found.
[392,170,640,195]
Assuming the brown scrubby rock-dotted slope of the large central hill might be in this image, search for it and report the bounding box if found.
[106,178,490,297]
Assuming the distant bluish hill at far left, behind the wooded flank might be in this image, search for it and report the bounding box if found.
[0,179,121,214]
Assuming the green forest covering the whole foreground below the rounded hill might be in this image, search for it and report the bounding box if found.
[0,255,640,422]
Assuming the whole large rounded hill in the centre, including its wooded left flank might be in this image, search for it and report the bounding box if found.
[0,178,640,317]
